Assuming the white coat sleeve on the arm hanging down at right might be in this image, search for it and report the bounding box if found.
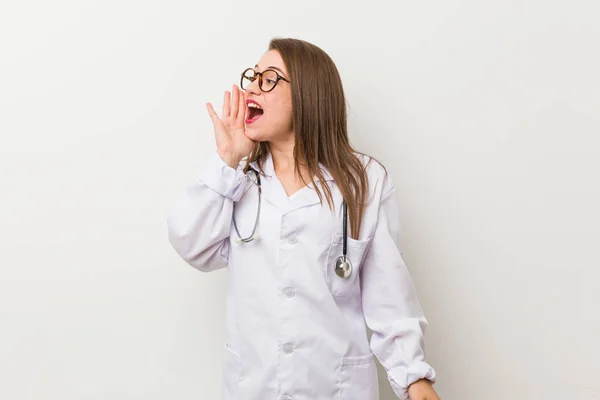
[361,171,435,400]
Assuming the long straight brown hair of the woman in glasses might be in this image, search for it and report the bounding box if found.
[246,38,387,239]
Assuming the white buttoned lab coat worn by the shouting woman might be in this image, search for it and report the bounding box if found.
[168,153,435,400]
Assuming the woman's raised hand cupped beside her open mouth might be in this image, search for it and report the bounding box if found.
[206,85,256,168]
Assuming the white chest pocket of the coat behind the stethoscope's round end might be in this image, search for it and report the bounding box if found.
[325,233,369,296]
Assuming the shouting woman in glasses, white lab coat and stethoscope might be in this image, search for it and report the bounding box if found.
[168,39,438,400]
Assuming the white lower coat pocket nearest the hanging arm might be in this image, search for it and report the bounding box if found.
[339,353,379,400]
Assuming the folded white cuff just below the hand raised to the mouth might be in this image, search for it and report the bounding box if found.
[200,152,248,201]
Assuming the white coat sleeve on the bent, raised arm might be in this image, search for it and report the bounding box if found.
[167,152,248,272]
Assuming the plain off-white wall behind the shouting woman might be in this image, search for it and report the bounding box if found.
[0,0,600,400]
